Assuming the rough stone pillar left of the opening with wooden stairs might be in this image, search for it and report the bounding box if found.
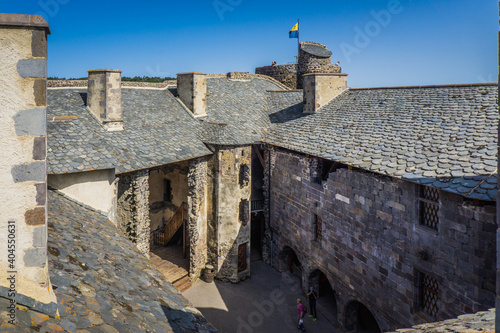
[116,169,151,258]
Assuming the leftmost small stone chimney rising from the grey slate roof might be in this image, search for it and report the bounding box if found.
[87,69,123,131]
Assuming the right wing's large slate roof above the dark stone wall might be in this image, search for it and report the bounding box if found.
[266,84,499,200]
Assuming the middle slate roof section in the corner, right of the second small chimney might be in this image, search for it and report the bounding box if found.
[199,78,282,145]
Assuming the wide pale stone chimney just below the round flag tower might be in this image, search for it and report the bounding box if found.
[303,73,347,113]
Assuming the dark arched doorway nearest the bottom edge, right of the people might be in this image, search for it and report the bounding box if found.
[345,301,381,333]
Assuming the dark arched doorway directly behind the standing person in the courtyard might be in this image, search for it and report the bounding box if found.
[309,269,337,323]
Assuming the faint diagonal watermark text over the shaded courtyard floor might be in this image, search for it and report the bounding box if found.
[236,274,301,333]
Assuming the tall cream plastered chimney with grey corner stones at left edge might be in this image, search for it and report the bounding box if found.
[0,14,57,314]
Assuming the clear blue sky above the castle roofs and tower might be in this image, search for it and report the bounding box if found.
[1,0,499,87]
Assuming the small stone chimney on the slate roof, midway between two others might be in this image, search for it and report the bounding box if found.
[177,72,207,117]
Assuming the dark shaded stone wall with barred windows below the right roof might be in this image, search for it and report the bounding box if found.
[270,148,496,331]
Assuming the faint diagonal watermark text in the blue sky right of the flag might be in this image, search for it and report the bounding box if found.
[339,0,411,63]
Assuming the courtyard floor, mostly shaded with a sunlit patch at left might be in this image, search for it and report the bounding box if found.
[183,261,339,333]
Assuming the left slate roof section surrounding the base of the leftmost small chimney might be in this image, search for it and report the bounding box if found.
[47,88,211,174]
